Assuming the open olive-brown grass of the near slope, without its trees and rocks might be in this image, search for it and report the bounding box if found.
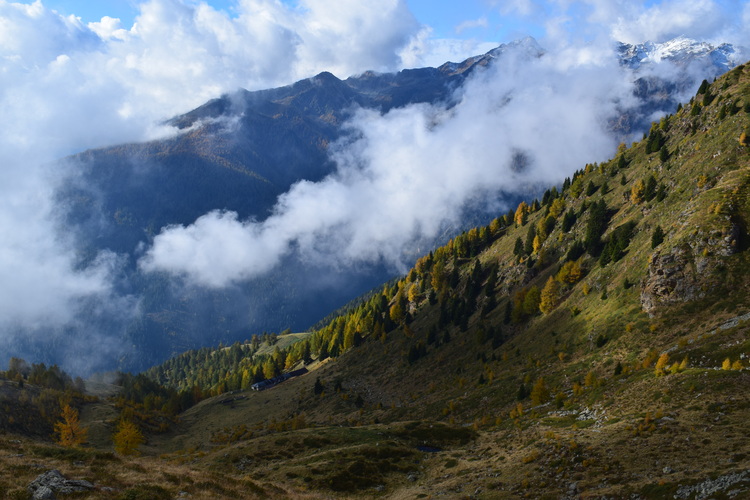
[0,64,750,498]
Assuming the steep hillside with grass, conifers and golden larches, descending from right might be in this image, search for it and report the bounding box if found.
[0,57,750,499]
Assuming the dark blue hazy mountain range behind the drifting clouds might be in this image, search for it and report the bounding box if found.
[53,38,740,369]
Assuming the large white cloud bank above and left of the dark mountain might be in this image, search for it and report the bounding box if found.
[0,0,421,372]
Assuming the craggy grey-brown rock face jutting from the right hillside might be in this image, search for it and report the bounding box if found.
[641,248,707,315]
